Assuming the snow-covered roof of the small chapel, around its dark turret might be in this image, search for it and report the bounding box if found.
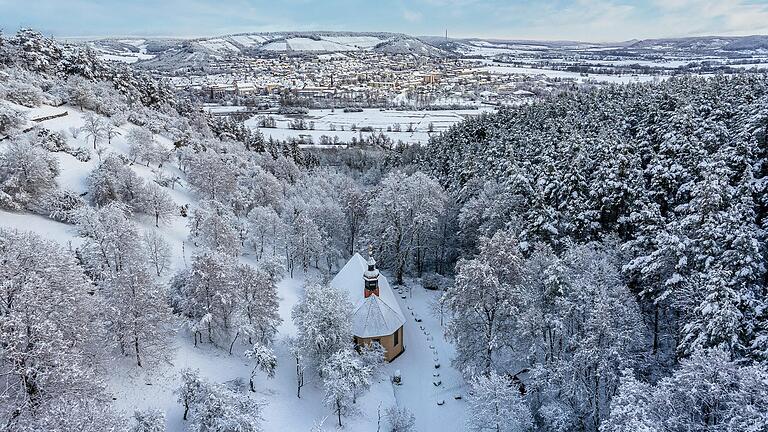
[331,254,405,338]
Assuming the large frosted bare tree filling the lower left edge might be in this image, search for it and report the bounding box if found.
[0,230,109,430]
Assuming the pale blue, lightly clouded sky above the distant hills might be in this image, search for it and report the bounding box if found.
[0,0,768,42]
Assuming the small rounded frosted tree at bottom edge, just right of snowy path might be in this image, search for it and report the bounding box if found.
[467,372,533,432]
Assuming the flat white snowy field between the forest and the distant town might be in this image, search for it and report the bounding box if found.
[246,106,493,144]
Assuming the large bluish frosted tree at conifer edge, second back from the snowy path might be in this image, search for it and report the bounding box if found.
[536,245,648,430]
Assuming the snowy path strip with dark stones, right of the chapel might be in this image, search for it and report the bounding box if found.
[390,286,466,432]
